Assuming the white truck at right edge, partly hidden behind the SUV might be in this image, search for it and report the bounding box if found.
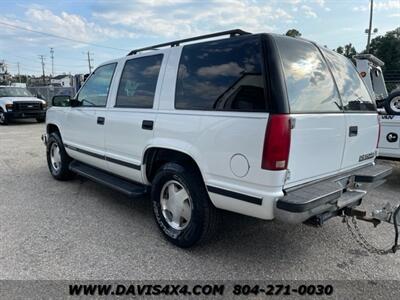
[354,54,400,160]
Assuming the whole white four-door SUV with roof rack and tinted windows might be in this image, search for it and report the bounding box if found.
[44,30,391,247]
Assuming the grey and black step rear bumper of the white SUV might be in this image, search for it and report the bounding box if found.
[274,164,392,223]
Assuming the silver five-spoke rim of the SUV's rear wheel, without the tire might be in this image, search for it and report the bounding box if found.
[160,180,192,230]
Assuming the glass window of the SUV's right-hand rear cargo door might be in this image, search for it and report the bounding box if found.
[322,49,376,111]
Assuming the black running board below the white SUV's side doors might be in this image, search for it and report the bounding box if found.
[69,160,148,198]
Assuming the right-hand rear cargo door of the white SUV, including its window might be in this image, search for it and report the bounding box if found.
[322,49,379,169]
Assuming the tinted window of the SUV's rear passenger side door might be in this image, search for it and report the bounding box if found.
[115,54,163,108]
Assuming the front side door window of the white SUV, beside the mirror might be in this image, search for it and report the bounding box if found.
[76,63,117,107]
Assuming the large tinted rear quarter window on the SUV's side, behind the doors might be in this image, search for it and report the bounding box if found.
[175,37,267,111]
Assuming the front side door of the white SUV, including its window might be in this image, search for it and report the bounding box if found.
[62,63,116,169]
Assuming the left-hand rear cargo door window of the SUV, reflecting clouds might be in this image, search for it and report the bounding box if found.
[276,37,341,113]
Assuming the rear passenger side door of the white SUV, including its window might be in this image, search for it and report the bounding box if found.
[105,52,167,182]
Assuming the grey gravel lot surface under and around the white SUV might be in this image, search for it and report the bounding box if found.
[0,121,400,280]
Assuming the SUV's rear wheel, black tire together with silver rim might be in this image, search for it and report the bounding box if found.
[151,163,218,248]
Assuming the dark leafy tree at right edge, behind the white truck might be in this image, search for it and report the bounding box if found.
[369,27,400,71]
